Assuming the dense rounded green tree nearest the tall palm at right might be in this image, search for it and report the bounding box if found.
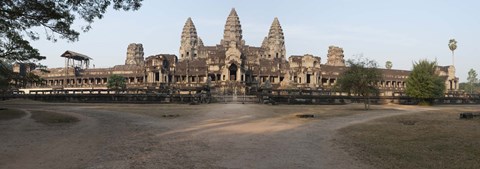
[406,60,445,104]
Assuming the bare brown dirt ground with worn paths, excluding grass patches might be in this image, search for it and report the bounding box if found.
[0,100,472,169]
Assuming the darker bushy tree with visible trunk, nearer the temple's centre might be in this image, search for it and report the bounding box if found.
[336,58,382,110]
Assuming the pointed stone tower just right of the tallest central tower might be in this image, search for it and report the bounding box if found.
[262,17,286,60]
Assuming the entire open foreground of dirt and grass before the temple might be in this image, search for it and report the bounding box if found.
[0,100,480,169]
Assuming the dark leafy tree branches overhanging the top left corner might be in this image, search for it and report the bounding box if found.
[0,0,142,62]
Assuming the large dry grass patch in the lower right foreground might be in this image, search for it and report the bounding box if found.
[339,109,480,169]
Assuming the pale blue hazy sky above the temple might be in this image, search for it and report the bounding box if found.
[32,0,480,82]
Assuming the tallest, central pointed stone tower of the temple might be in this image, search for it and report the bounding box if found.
[220,8,245,48]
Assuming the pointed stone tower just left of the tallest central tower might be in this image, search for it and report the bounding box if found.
[179,18,203,59]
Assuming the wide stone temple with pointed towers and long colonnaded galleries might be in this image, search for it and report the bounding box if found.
[15,9,458,96]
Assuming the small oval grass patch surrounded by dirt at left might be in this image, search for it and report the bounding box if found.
[31,111,79,125]
